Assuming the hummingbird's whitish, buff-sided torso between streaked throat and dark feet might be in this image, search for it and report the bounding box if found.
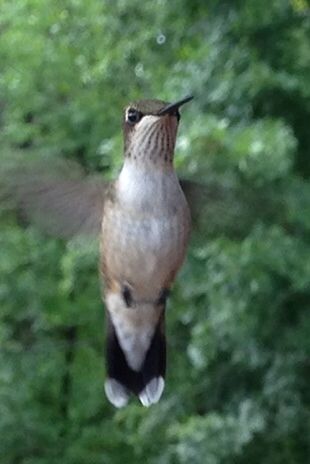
[102,161,189,298]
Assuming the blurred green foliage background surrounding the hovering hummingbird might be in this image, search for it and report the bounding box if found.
[0,0,310,464]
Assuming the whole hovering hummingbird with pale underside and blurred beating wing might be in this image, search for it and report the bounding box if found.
[3,97,193,407]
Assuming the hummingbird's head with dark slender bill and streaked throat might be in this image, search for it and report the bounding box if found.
[123,97,193,164]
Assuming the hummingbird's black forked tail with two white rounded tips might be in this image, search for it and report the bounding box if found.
[105,310,166,407]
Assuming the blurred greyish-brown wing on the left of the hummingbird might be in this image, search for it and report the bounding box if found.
[0,161,111,238]
